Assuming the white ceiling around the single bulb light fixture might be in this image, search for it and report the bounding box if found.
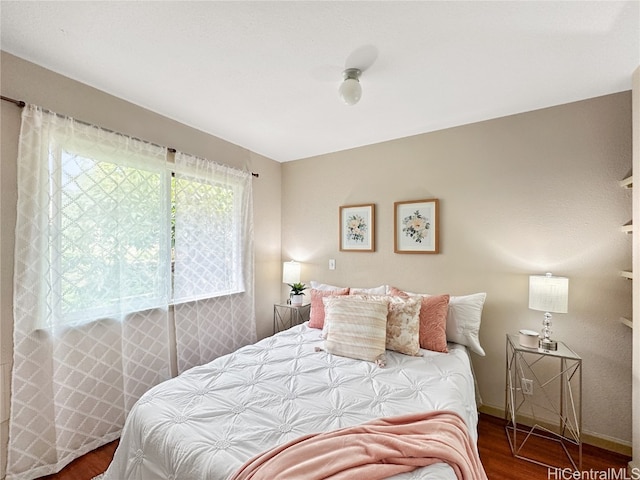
[0,0,640,162]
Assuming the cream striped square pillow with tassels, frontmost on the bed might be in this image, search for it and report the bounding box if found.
[323,296,389,364]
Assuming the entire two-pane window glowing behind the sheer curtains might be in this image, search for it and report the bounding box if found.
[48,133,244,326]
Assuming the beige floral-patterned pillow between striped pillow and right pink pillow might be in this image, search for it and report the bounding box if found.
[349,294,421,356]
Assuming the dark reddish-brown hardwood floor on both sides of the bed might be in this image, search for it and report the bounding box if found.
[42,414,630,480]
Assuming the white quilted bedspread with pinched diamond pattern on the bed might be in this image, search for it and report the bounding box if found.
[104,323,477,480]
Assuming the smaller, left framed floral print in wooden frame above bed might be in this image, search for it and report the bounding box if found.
[340,203,376,252]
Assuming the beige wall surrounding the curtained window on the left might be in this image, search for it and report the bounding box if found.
[0,52,281,478]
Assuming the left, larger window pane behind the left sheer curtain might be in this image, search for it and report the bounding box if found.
[43,138,170,326]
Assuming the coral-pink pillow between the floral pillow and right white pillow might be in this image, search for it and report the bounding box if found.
[391,287,449,353]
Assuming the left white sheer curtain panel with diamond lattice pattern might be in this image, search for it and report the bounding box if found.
[7,105,171,479]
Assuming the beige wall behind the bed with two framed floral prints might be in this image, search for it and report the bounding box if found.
[282,92,632,445]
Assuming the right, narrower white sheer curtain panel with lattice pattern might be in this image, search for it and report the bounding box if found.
[174,152,256,373]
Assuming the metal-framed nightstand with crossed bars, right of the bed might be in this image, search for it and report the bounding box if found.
[505,334,582,470]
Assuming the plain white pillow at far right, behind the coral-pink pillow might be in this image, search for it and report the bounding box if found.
[392,288,487,357]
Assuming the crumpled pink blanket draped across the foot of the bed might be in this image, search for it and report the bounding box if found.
[230,411,487,480]
